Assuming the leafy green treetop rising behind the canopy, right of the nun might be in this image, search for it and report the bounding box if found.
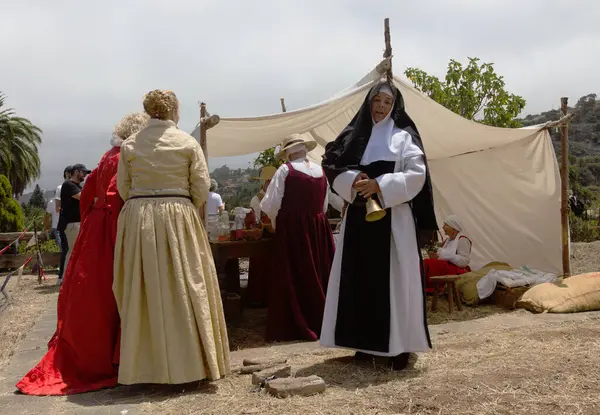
[404,58,525,127]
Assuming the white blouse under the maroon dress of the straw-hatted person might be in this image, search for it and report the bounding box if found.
[260,159,330,226]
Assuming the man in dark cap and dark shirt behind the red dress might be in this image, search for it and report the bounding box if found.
[58,164,91,284]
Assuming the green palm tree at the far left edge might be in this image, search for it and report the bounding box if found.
[0,92,42,197]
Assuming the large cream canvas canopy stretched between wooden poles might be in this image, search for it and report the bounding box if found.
[192,63,562,274]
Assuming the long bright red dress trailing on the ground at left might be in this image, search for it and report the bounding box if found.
[17,147,123,395]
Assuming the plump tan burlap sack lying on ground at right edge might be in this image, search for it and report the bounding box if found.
[517,272,600,313]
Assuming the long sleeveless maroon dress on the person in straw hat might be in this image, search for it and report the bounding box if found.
[266,163,335,341]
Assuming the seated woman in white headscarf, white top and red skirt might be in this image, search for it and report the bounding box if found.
[423,215,472,293]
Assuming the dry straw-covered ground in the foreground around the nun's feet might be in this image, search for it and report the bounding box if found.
[118,320,600,415]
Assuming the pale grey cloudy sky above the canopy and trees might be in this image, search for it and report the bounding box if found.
[0,0,600,192]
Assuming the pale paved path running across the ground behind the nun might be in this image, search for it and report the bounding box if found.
[0,307,600,415]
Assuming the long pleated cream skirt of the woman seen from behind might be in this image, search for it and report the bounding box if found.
[113,198,229,385]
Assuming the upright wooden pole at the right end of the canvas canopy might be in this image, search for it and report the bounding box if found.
[560,97,571,277]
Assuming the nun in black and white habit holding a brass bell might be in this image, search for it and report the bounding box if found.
[320,82,437,370]
